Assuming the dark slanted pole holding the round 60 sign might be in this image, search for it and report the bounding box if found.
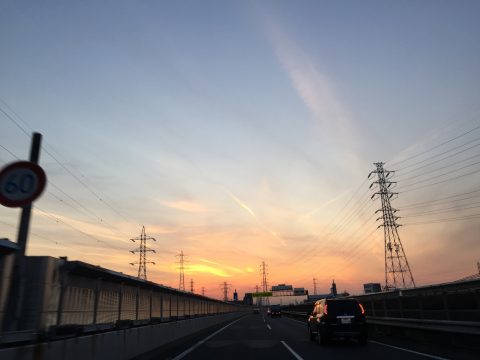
[3,133,42,331]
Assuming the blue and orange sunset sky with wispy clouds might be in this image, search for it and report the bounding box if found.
[0,0,480,298]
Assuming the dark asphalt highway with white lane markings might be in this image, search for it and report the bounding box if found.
[149,314,474,360]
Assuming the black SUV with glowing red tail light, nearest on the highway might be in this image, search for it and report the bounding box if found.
[308,299,367,345]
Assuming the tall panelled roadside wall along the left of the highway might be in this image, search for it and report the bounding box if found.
[0,257,244,346]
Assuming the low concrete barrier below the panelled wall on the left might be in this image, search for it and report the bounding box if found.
[0,312,244,360]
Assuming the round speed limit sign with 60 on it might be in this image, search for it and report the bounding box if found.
[0,161,47,207]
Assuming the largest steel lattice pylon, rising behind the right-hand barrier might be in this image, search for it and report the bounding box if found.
[368,162,415,291]
